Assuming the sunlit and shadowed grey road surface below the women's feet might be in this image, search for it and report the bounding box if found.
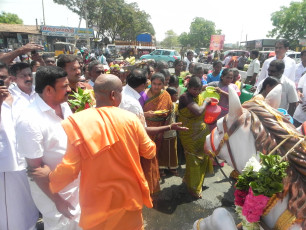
[143,165,238,230]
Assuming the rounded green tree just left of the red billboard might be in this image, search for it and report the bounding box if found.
[178,17,221,48]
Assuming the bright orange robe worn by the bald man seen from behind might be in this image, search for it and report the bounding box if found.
[49,106,156,229]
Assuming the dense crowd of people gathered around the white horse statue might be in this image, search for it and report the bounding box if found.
[0,39,306,230]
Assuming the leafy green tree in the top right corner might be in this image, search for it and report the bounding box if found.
[267,0,306,49]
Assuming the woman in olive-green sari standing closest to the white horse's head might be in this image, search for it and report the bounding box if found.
[178,77,213,198]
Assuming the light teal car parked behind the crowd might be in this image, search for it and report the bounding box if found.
[139,49,181,68]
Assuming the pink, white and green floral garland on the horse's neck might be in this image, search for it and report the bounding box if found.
[234,153,289,230]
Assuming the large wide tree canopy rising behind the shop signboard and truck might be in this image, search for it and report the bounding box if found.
[53,0,155,41]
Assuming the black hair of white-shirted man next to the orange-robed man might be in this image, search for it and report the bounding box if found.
[35,66,67,93]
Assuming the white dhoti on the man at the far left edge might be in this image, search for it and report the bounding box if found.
[0,170,38,230]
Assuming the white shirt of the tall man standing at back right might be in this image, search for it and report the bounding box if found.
[255,56,296,86]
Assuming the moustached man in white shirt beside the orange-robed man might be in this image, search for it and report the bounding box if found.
[16,66,80,230]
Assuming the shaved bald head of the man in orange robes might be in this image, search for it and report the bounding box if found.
[94,74,122,107]
